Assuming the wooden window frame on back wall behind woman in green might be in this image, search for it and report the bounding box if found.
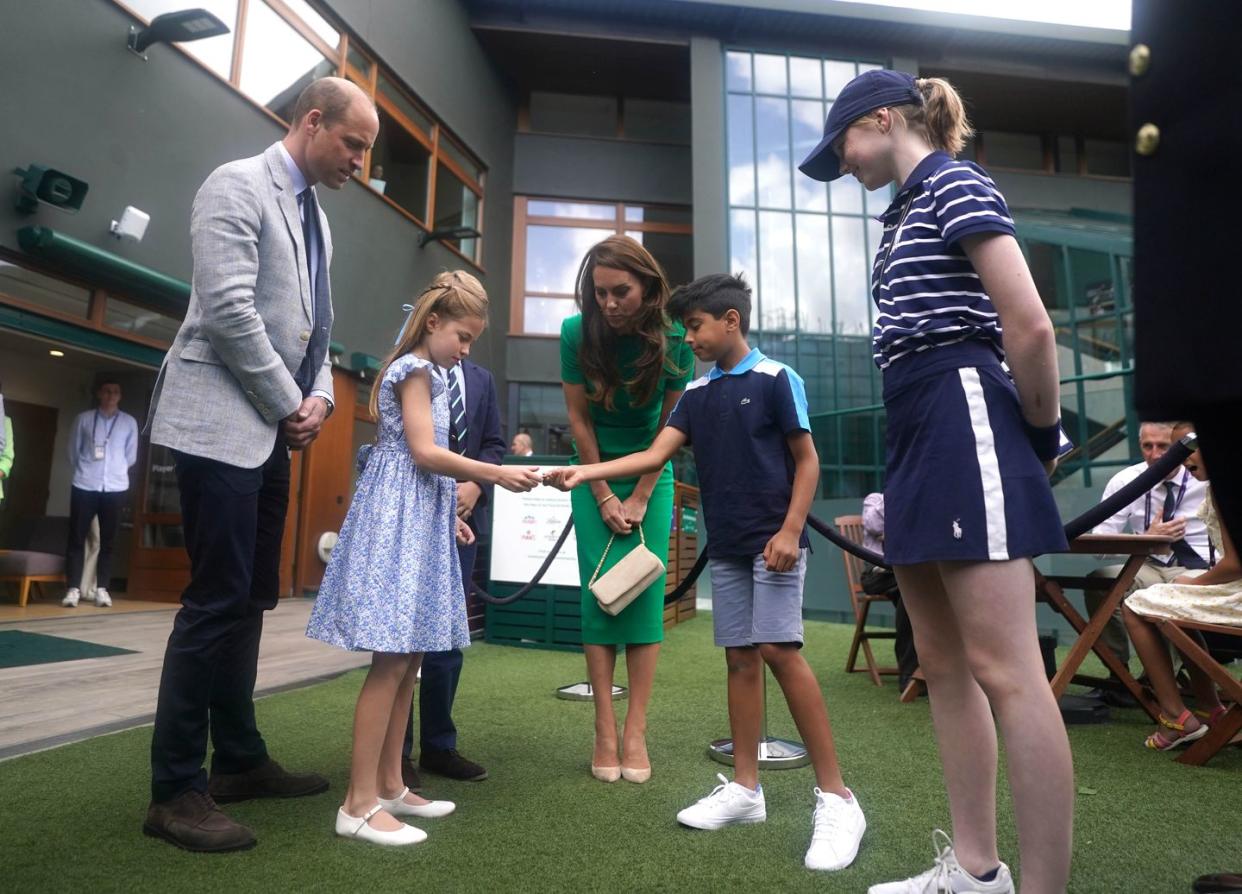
[508,195,694,339]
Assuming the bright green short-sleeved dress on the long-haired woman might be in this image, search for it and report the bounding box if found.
[560,315,694,646]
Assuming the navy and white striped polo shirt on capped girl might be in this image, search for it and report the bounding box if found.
[871,151,1013,370]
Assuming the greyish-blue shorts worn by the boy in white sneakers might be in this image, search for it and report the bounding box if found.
[712,548,806,647]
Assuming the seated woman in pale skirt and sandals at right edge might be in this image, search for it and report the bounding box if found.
[1123,422,1242,751]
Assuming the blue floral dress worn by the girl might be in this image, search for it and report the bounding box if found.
[307,354,469,653]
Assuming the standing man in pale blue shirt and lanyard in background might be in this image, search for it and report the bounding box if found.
[61,379,138,608]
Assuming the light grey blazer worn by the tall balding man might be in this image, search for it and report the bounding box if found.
[148,143,332,468]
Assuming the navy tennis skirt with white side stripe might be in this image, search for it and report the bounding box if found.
[884,341,1067,565]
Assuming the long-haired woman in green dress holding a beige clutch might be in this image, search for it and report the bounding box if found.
[560,236,694,782]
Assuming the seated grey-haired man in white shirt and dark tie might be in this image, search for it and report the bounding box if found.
[1086,422,1211,675]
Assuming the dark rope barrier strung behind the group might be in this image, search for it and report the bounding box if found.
[472,433,1197,605]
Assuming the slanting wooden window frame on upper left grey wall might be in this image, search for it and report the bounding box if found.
[112,0,487,273]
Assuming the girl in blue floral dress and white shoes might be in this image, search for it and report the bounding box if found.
[307,271,540,844]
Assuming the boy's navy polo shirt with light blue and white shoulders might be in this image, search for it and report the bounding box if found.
[668,348,811,559]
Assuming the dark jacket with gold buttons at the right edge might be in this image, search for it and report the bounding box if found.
[1129,0,1242,418]
